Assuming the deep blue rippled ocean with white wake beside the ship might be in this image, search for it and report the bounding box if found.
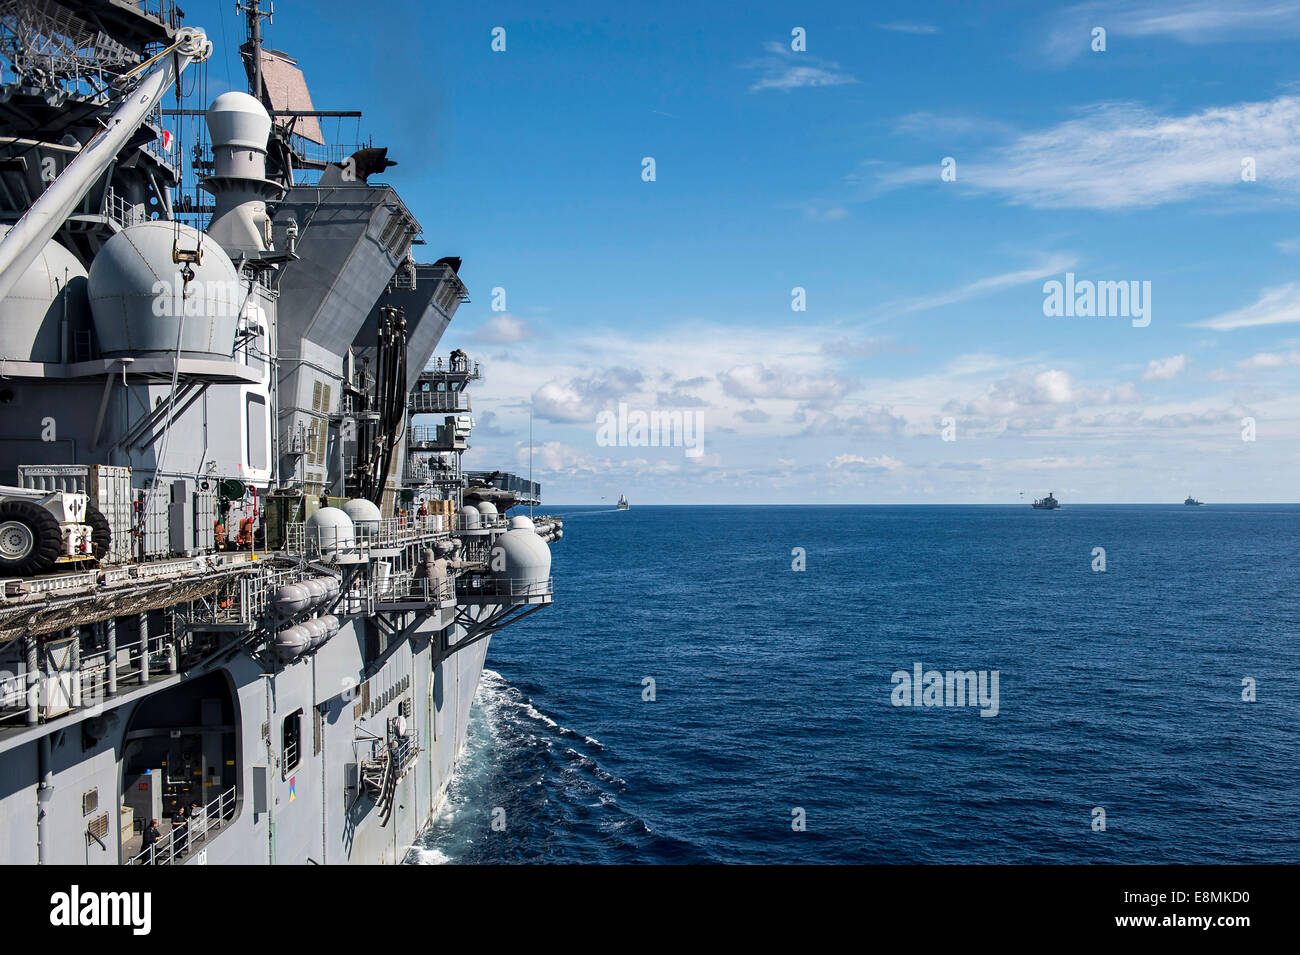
[410,504,1300,863]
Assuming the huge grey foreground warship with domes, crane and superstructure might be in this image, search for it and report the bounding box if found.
[0,0,563,865]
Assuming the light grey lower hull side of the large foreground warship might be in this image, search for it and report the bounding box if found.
[0,620,488,865]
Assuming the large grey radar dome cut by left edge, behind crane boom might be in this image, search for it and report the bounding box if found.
[0,226,90,361]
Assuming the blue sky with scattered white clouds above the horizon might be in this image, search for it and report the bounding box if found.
[187,0,1300,504]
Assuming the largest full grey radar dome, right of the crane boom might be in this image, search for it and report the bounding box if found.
[88,221,247,360]
